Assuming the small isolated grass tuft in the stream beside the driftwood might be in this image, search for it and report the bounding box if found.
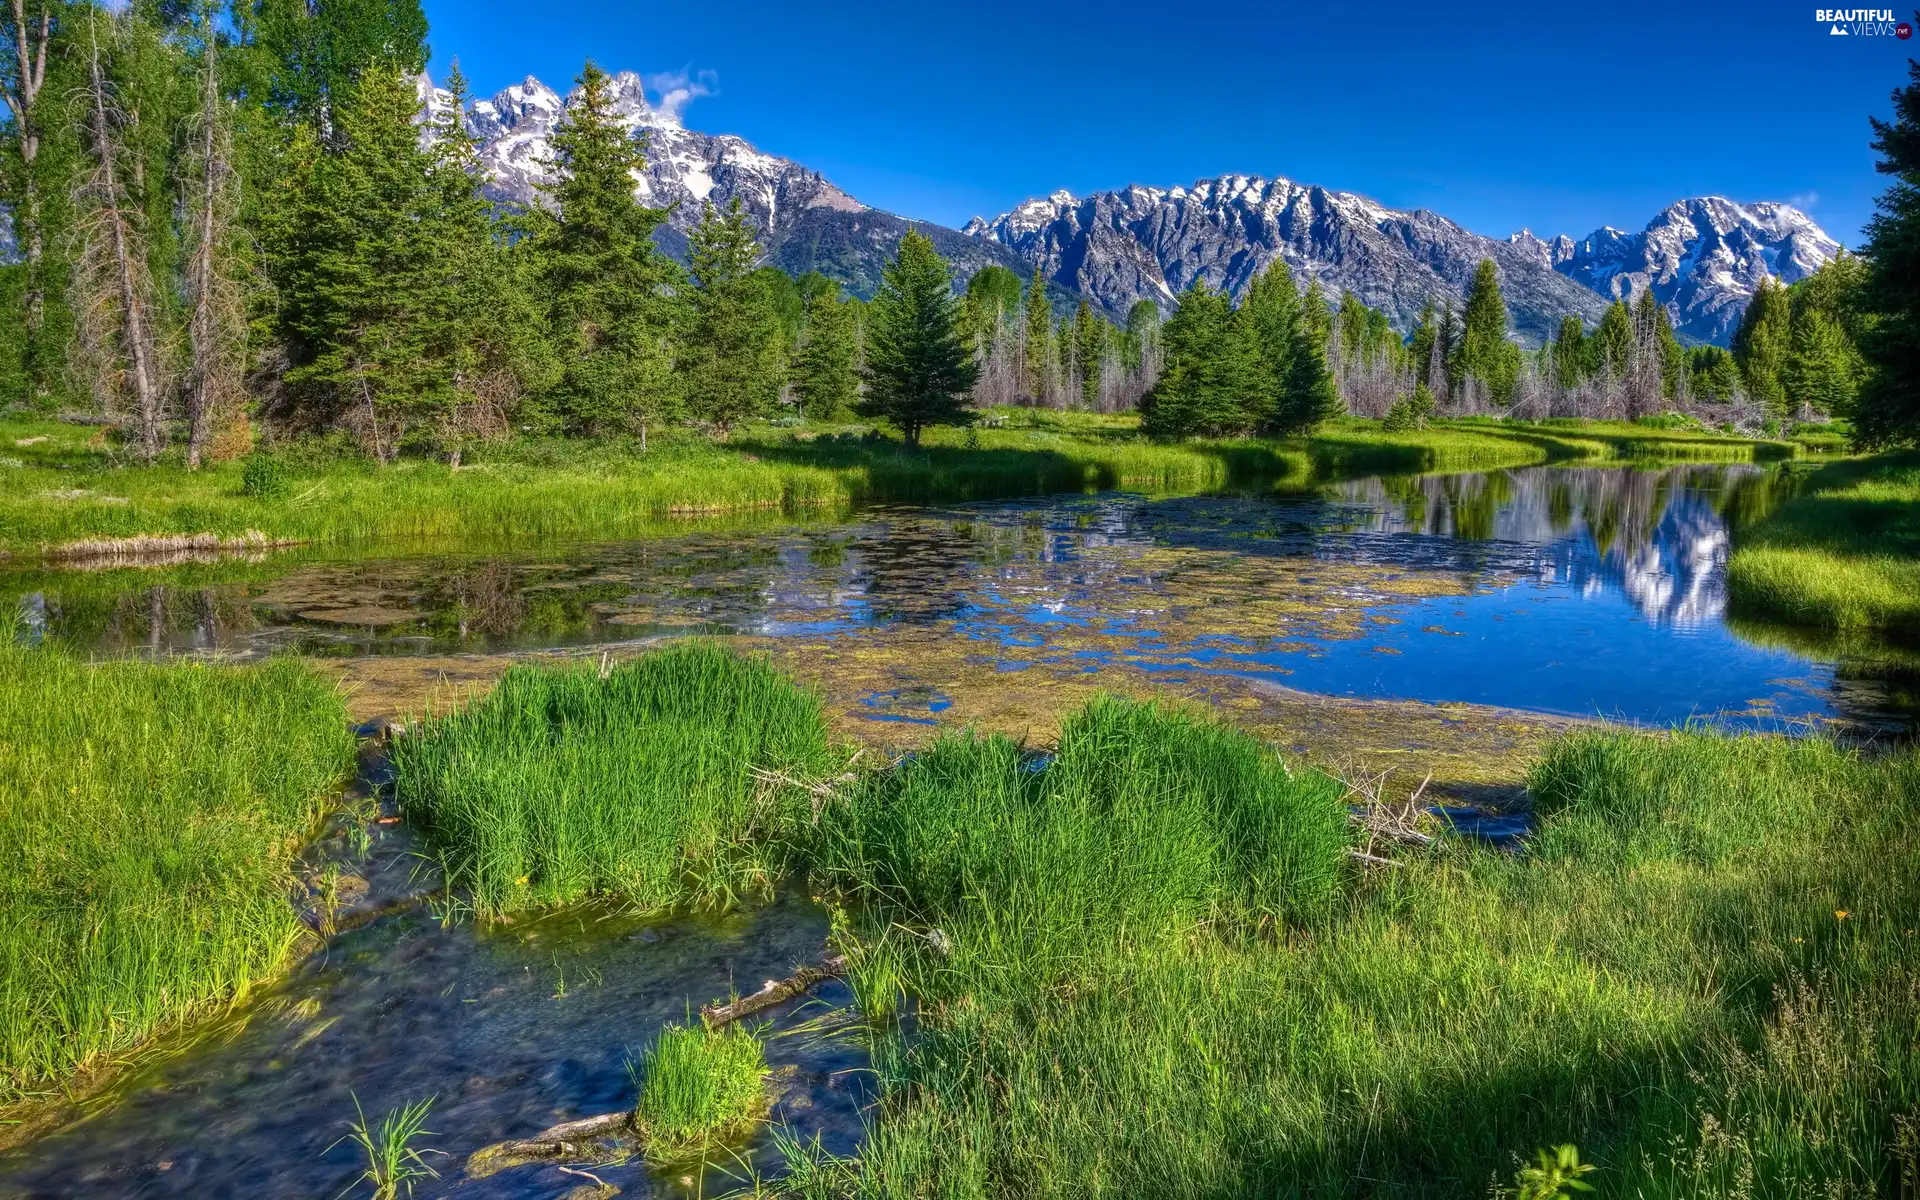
[634,1025,766,1162]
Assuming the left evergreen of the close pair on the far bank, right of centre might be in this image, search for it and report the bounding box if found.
[1140,280,1269,438]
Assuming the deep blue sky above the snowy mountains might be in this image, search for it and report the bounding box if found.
[426,0,1920,246]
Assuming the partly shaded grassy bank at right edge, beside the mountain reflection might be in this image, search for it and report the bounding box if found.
[1726,453,1920,639]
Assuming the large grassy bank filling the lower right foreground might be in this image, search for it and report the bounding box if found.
[403,651,1920,1198]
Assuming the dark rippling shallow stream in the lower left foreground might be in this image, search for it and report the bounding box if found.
[0,897,872,1200]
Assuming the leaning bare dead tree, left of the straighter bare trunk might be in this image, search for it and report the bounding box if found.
[73,15,165,463]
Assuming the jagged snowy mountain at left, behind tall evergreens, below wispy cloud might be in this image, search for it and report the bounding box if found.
[420,71,1020,296]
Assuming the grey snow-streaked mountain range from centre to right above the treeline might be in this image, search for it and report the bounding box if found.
[964,175,1839,344]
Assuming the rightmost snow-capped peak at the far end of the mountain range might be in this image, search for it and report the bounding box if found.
[1515,196,1841,346]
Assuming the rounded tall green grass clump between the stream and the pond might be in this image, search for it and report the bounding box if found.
[394,641,833,916]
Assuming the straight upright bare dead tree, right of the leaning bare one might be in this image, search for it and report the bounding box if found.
[184,6,246,470]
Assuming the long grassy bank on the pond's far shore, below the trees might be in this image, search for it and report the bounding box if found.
[0,411,1793,557]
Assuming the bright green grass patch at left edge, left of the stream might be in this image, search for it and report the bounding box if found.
[0,630,353,1102]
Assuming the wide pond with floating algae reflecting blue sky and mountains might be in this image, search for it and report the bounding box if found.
[15,467,1910,728]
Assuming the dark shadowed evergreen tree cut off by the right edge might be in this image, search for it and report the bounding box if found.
[1853,60,1920,445]
